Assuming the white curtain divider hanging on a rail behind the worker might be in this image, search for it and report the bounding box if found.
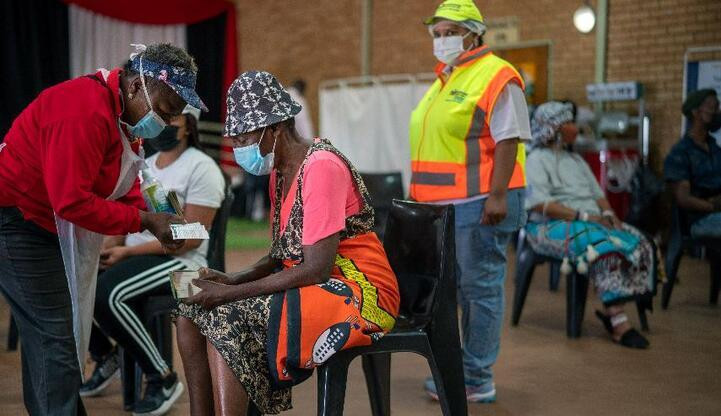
[319,74,434,192]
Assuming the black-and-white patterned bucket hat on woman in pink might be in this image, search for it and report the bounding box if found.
[223,71,303,137]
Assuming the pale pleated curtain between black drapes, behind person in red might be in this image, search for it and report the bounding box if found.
[70,5,186,77]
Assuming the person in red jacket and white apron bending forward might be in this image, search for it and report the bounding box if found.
[0,44,207,415]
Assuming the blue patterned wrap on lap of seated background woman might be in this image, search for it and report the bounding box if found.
[526,220,657,304]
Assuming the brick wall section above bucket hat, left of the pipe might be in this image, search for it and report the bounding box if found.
[236,0,361,129]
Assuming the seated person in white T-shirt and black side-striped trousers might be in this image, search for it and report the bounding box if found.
[80,107,225,415]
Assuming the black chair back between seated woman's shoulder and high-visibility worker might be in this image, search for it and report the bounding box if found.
[360,172,403,241]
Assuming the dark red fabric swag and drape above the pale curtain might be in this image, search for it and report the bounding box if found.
[62,0,238,117]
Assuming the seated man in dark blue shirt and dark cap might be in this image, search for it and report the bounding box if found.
[663,89,721,238]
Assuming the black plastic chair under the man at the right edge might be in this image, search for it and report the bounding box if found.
[661,204,721,309]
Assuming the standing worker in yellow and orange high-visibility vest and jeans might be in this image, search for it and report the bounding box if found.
[409,0,531,402]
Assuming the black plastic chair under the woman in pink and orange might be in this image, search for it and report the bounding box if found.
[310,200,468,416]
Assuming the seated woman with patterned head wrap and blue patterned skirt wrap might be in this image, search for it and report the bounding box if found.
[526,101,656,348]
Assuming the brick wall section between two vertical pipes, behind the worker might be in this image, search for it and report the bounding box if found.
[373,0,595,106]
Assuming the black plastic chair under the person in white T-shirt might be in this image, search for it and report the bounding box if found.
[119,189,233,411]
